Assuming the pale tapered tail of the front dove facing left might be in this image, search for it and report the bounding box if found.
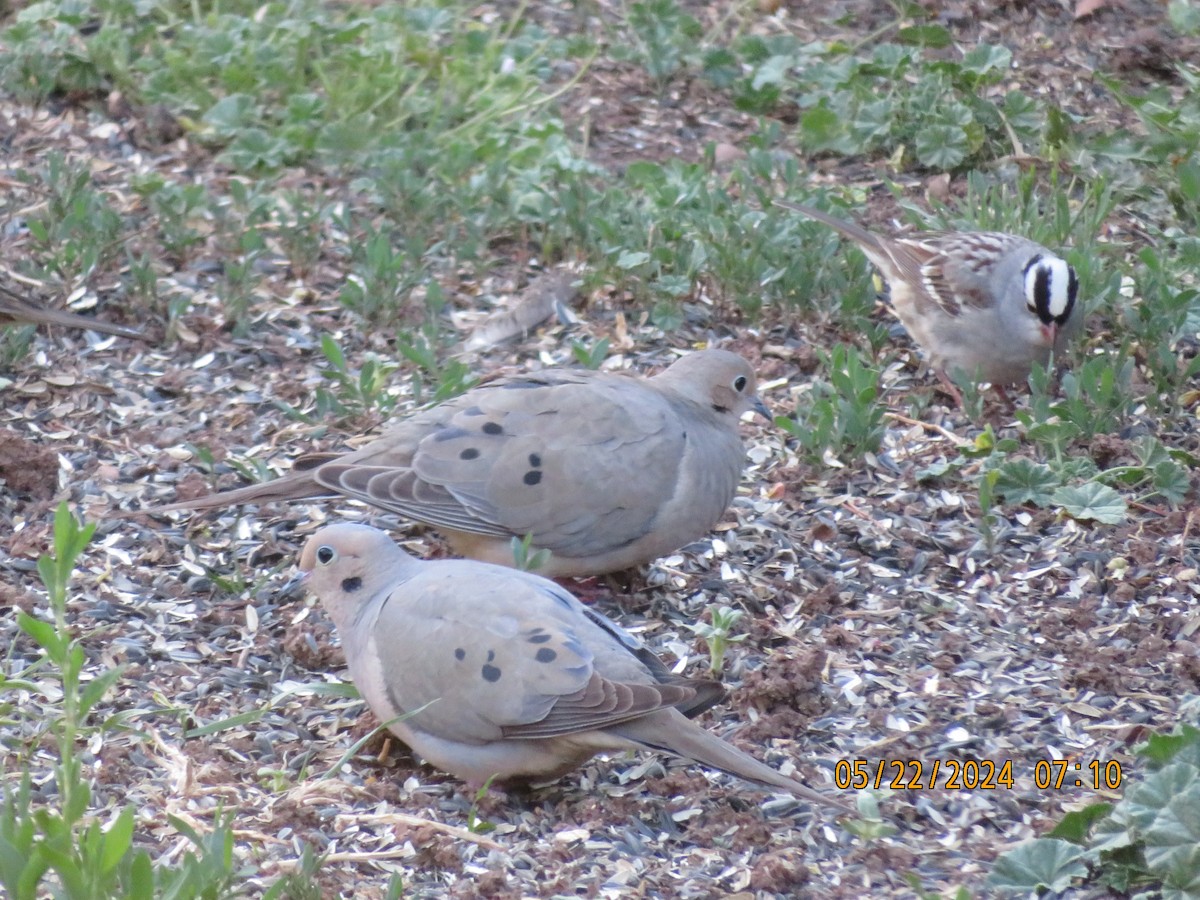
[607,709,854,812]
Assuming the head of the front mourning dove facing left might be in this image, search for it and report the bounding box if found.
[300,523,416,629]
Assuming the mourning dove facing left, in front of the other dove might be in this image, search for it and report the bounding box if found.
[300,524,852,811]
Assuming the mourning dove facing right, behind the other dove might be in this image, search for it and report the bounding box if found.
[145,349,769,577]
